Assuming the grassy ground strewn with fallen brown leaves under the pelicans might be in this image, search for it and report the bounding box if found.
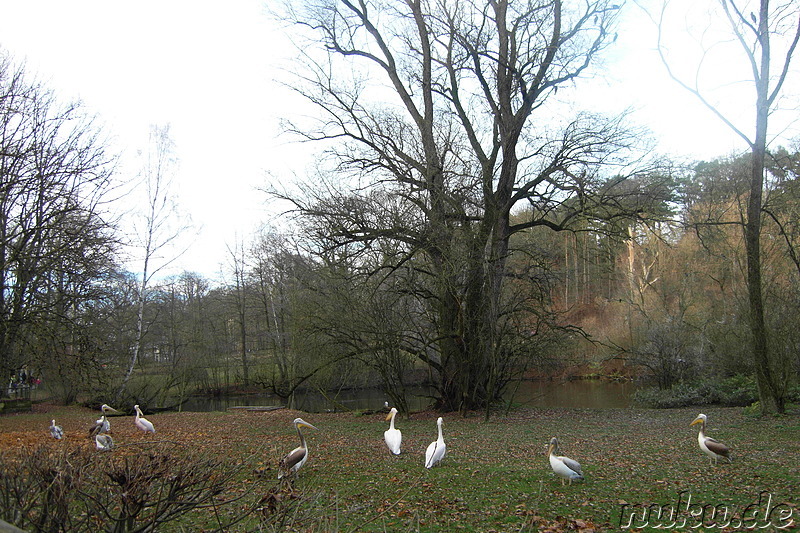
[0,407,800,532]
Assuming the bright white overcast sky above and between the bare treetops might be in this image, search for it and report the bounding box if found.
[0,0,796,277]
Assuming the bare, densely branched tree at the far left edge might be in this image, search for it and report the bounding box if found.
[0,54,115,386]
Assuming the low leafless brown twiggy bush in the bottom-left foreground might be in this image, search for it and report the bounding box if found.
[0,438,253,532]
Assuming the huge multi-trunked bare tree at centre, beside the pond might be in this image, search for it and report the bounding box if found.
[273,0,668,410]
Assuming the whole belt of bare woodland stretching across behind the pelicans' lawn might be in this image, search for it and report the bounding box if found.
[0,0,800,413]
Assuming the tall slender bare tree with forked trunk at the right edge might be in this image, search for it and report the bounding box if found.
[658,0,800,413]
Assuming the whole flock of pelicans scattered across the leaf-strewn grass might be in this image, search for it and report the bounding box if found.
[45,404,731,485]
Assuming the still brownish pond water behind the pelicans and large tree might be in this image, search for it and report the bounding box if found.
[183,380,636,413]
